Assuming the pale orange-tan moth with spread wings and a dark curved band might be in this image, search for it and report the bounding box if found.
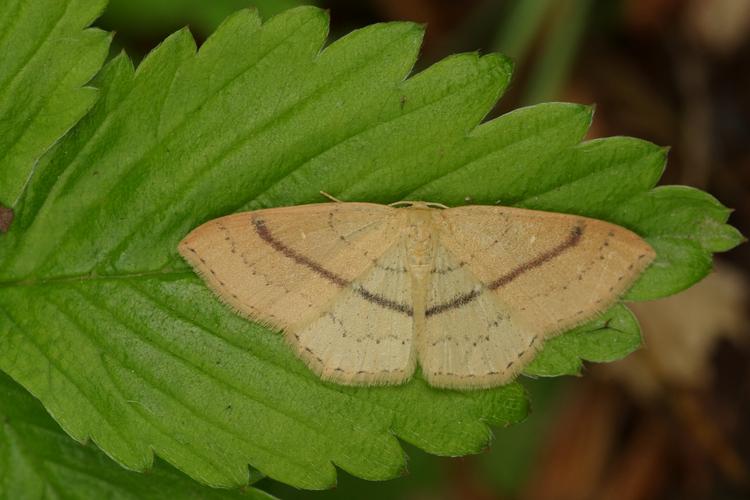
[179,202,655,389]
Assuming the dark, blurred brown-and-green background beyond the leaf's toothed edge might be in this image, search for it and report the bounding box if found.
[97,0,750,500]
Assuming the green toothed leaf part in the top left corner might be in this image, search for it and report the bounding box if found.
[0,0,110,207]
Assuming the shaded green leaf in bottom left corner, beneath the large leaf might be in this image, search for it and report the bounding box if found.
[0,373,273,500]
